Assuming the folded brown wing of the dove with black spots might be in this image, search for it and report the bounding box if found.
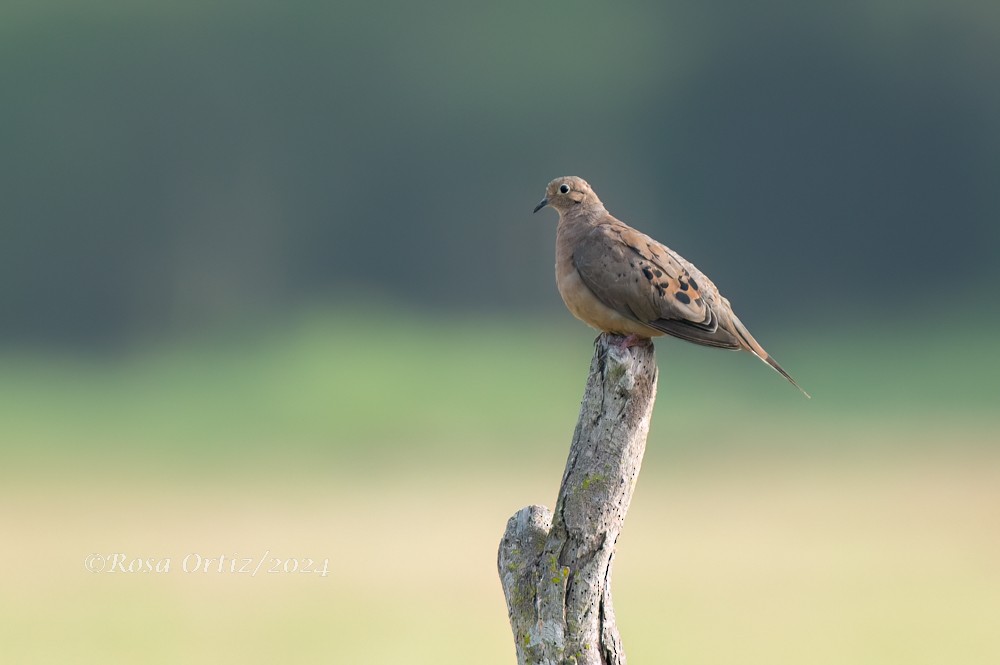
[573,218,743,349]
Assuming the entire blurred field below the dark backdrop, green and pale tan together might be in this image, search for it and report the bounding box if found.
[0,315,1000,665]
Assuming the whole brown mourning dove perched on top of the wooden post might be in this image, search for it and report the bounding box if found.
[534,176,809,397]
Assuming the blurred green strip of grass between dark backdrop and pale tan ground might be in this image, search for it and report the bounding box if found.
[0,312,1000,462]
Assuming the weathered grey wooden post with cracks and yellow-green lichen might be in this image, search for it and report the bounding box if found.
[497,333,657,665]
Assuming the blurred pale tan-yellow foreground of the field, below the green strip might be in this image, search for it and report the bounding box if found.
[0,451,1000,665]
